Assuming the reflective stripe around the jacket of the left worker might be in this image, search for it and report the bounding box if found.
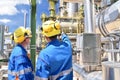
[8,67,32,76]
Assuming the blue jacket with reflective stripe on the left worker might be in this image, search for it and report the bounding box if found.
[8,44,34,80]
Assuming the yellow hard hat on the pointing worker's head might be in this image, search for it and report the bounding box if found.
[41,21,60,37]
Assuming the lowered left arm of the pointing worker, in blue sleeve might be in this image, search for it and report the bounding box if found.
[35,52,50,80]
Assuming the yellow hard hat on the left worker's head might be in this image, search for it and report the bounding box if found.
[12,27,32,43]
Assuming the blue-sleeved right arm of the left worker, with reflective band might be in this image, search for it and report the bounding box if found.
[15,55,34,80]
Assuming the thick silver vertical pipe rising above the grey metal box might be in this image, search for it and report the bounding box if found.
[84,0,95,33]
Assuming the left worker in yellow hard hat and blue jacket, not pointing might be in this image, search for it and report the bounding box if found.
[8,27,34,80]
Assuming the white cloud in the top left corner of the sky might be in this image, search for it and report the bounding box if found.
[0,0,30,15]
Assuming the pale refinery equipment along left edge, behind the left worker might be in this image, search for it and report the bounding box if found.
[0,25,13,80]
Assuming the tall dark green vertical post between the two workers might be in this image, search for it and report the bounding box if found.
[30,0,36,70]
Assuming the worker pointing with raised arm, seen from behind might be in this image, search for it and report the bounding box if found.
[35,21,73,80]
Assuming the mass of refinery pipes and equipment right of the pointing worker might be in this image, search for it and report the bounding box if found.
[41,0,120,80]
